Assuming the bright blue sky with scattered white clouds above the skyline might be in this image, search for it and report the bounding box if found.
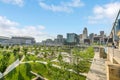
[0,0,120,42]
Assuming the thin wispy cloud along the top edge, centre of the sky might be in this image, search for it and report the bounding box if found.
[39,0,84,13]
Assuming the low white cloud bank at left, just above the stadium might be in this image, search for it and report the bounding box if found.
[0,16,50,42]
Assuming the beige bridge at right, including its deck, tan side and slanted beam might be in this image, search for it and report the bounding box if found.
[86,10,120,80]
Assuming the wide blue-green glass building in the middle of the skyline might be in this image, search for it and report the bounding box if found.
[67,33,79,44]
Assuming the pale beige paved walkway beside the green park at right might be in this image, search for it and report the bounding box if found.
[86,52,106,80]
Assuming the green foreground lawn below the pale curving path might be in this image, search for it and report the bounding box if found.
[4,63,86,80]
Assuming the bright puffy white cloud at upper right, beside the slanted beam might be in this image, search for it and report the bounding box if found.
[88,2,120,24]
